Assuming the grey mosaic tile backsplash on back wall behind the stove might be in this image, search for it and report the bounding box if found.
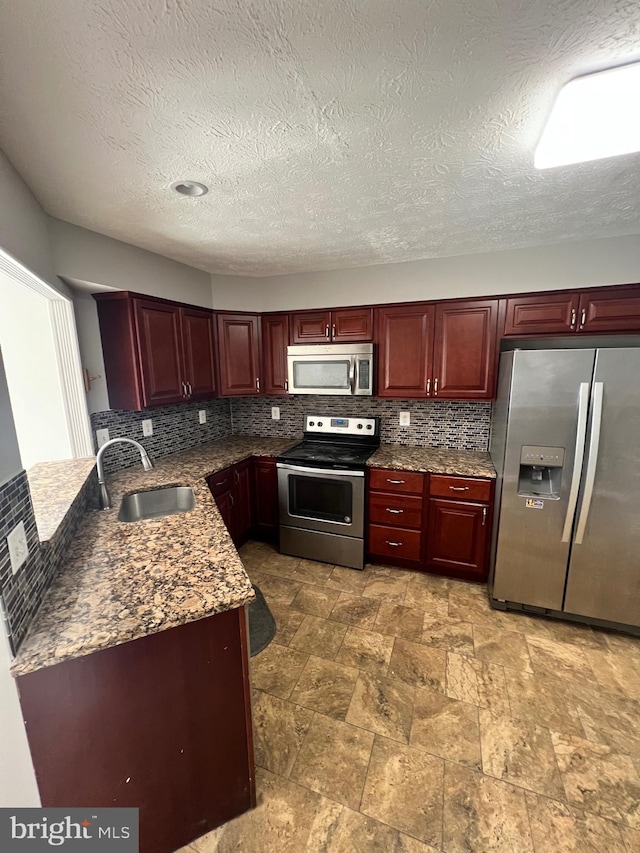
[231,395,491,450]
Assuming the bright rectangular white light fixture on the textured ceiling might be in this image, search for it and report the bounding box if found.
[533,62,640,169]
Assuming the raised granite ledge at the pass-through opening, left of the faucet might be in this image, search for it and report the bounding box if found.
[27,456,96,543]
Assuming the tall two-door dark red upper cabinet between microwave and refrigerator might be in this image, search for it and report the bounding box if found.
[376,299,498,400]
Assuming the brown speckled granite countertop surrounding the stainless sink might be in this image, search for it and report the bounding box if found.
[12,436,295,676]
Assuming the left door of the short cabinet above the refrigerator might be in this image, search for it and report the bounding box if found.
[504,292,579,337]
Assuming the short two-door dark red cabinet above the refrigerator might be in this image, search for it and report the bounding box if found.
[504,285,640,337]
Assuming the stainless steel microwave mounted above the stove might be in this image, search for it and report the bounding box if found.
[287,344,373,396]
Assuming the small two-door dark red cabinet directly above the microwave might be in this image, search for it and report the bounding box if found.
[290,307,373,344]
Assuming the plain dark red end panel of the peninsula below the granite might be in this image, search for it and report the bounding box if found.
[16,607,255,853]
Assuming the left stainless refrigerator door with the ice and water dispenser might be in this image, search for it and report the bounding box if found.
[492,350,595,610]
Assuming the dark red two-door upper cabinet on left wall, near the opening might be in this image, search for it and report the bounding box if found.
[94,291,216,410]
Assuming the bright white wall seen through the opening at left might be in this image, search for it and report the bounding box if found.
[0,272,74,468]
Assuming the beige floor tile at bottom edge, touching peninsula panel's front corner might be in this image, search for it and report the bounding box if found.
[191,769,344,853]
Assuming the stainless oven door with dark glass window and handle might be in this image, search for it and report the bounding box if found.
[278,462,364,538]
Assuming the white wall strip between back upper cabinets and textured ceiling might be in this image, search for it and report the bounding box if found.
[212,235,640,311]
